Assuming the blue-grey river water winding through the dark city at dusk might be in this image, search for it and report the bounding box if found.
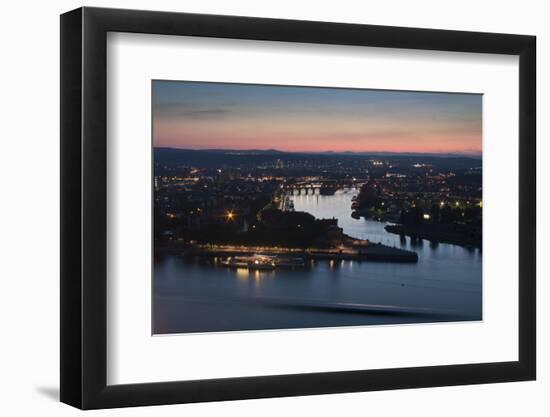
[153,190,482,334]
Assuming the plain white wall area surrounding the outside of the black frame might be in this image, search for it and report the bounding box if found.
[0,0,550,416]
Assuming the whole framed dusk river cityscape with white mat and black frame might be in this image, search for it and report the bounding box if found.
[61,8,536,409]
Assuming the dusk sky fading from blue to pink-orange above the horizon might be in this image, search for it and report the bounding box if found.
[152,81,482,155]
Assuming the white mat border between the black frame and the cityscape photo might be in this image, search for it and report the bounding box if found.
[107,34,519,384]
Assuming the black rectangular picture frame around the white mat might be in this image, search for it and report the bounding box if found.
[60,7,536,409]
